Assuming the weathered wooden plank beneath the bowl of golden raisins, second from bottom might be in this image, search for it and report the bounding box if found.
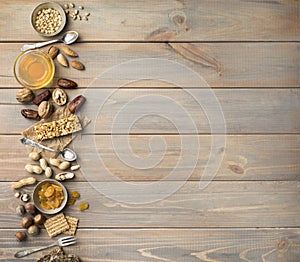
[0,181,300,228]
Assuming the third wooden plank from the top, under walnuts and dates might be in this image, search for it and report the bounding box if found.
[0,88,300,134]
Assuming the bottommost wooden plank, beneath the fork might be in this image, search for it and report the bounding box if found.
[0,228,300,262]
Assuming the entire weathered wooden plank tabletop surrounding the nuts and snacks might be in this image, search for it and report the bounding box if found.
[0,0,300,262]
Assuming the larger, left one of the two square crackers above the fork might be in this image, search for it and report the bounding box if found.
[44,213,70,237]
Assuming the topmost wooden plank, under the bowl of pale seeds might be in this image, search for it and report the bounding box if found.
[0,0,300,41]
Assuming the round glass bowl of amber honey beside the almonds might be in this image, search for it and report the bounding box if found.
[14,49,55,90]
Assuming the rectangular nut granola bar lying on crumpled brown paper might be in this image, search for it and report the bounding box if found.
[34,115,82,141]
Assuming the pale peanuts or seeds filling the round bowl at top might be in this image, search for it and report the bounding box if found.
[35,8,62,34]
